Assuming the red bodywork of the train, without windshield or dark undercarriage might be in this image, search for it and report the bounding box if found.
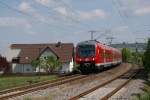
[75,40,122,66]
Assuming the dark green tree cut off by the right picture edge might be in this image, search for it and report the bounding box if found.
[144,39,150,72]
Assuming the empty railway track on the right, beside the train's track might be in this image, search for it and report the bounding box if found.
[69,64,139,100]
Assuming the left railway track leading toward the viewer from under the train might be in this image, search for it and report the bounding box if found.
[0,74,88,100]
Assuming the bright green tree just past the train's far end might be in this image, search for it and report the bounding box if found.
[122,48,132,62]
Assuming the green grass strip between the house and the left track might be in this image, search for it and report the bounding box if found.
[0,75,58,90]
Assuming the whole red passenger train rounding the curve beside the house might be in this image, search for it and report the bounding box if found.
[75,40,122,72]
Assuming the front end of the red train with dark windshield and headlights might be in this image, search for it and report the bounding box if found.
[76,41,96,72]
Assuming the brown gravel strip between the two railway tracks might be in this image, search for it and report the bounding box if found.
[13,64,132,100]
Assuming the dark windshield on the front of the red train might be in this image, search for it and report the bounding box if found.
[78,45,95,57]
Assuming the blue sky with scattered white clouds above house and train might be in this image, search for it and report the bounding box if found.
[0,0,150,59]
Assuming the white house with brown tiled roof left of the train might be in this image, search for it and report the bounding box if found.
[11,42,74,73]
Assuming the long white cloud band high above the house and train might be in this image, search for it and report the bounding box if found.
[54,7,108,21]
